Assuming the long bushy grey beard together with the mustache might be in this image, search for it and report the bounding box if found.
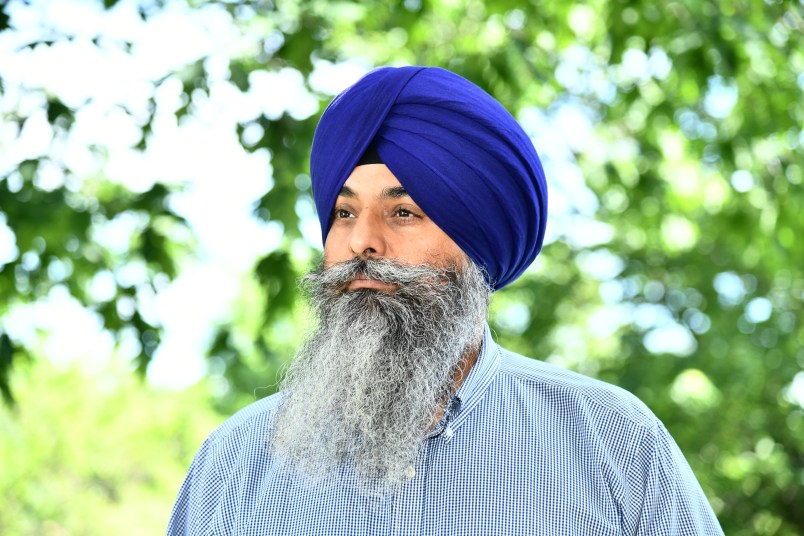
[268,258,490,495]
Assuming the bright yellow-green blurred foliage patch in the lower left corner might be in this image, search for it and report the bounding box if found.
[0,361,221,535]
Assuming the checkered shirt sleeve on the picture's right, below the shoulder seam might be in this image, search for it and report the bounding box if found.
[627,422,723,536]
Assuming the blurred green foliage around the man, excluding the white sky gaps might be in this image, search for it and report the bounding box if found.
[0,0,804,535]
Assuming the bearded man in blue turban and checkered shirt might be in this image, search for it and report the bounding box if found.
[168,67,722,535]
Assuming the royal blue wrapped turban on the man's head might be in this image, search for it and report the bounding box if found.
[310,67,547,289]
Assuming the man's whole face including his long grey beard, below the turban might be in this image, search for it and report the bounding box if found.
[269,164,489,494]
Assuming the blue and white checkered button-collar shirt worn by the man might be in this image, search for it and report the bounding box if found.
[167,329,723,536]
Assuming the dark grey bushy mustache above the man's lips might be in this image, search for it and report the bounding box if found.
[301,257,462,293]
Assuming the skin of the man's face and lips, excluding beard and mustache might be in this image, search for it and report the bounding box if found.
[324,164,463,284]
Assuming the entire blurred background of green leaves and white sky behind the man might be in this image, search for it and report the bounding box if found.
[0,0,804,535]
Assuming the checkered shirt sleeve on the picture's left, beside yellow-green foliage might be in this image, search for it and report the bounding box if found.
[167,439,224,536]
